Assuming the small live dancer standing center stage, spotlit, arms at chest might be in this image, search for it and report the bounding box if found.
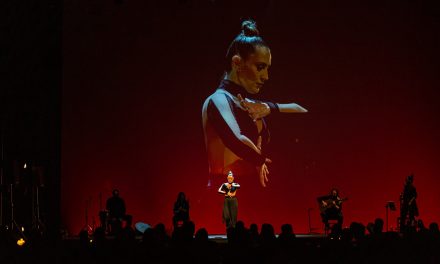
[218,171,240,229]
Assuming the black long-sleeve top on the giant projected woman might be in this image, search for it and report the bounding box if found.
[202,80,279,175]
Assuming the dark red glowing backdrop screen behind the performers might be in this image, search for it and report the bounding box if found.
[61,1,440,234]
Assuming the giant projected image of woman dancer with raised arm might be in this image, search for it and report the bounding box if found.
[202,20,307,187]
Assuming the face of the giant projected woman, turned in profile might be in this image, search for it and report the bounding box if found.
[237,46,272,94]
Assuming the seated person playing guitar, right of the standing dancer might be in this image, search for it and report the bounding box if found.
[318,188,344,230]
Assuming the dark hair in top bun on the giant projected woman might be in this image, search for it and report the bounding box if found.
[225,19,269,72]
